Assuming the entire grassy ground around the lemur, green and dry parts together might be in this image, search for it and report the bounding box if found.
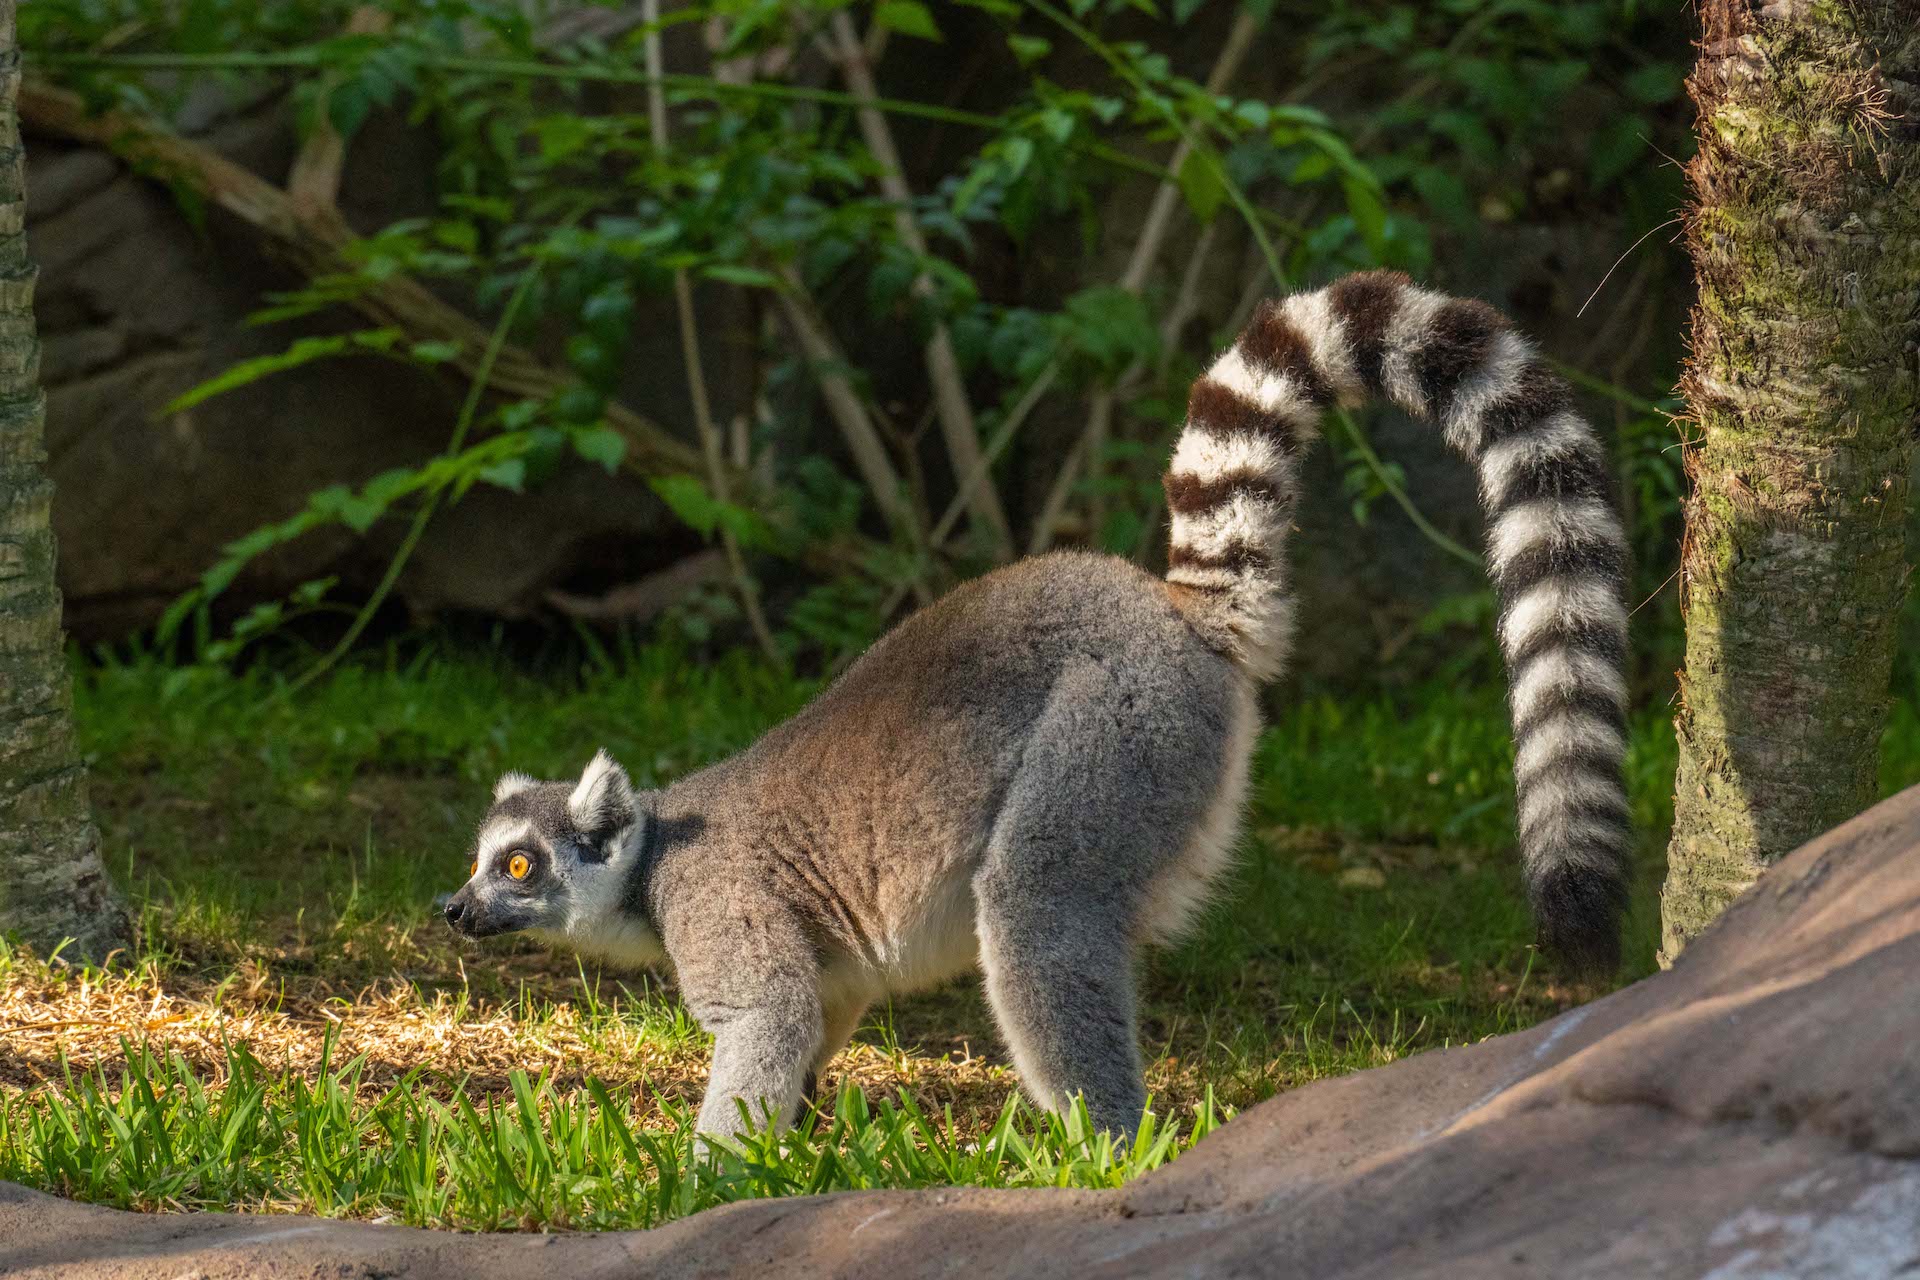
[0,647,1920,1230]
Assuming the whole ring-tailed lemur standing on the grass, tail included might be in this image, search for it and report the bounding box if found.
[447,273,1628,1134]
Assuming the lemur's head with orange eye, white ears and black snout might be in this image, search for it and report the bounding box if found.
[447,750,645,940]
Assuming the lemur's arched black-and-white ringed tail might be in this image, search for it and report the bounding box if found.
[1165,271,1628,973]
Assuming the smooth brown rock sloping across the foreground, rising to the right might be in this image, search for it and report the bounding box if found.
[0,789,1920,1280]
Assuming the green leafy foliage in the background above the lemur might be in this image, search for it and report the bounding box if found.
[21,0,1684,675]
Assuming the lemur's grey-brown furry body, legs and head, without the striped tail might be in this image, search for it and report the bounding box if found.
[447,553,1252,1136]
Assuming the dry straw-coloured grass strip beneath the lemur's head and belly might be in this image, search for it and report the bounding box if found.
[0,952,1082,1132]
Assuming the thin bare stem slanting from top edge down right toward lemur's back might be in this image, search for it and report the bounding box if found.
[829,10,1012,560]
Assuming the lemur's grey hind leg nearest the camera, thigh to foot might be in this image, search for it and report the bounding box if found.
[973,662,1231,1136]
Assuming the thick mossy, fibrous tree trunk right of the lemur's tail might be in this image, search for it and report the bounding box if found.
[1661,0,1920,963]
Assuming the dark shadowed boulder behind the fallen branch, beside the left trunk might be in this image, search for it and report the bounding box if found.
[27,107,714,641]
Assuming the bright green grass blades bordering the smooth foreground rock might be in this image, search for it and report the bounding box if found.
[0,1038,1217,1230]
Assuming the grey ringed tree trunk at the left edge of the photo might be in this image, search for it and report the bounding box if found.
[0,0,127,960]
